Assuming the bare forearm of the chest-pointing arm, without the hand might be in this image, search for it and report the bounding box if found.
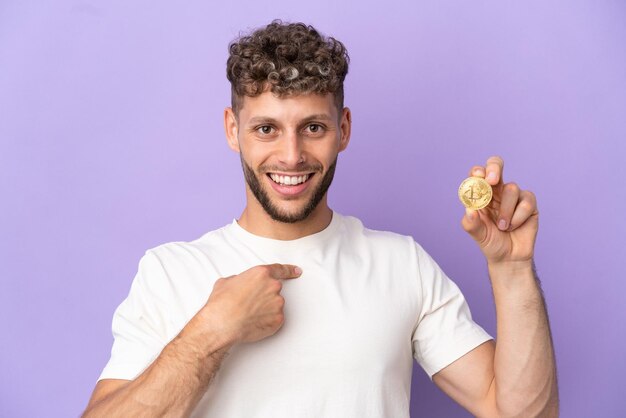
[83,313,233,417]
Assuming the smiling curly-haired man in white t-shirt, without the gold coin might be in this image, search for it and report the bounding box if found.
[84,21,558,418]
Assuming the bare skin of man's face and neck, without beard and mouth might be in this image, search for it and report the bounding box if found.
[224,92,352,240]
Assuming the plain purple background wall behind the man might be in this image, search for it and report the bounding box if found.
[0,0,626,417]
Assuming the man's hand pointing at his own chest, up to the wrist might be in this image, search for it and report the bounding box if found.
[201,264,302,343]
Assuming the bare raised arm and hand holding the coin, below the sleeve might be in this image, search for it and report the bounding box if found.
[433,156,559,417]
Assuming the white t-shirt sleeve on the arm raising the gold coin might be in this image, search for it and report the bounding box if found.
[412,243,493,380]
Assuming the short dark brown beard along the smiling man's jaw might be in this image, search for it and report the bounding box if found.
[239,153,337,223]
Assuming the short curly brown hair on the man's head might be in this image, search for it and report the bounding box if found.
[226,19,350,115]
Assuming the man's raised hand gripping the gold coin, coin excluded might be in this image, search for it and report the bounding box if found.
[461,157,539,265]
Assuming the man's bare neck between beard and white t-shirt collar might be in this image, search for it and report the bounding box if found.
[237,196,333,240]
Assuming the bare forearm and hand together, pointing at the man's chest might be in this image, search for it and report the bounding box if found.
[83,264,302,417]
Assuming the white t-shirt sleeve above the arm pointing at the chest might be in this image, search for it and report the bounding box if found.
[98,251,168,380]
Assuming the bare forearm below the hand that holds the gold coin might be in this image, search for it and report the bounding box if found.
[489,263,558,417]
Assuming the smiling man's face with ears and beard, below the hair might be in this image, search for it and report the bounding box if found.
[225,92,351,223]
